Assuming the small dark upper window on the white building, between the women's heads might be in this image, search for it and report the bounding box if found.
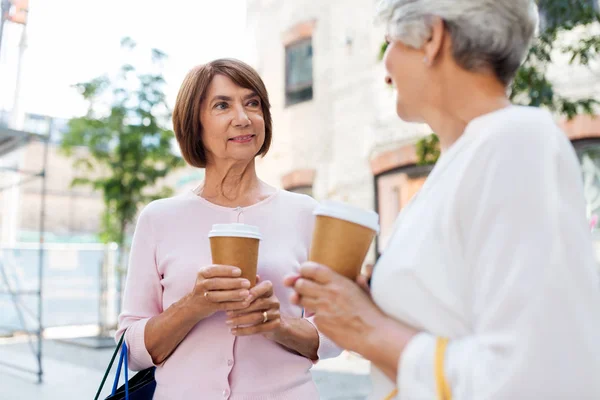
[285,38,313,106]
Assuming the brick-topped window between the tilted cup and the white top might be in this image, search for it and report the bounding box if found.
[375,166,432,257]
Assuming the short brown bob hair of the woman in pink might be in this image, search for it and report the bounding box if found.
[173,59,273,168]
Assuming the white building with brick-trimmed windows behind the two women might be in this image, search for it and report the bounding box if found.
[247,0,600,260]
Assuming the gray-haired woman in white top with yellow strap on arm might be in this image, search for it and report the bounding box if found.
[286,0,600,400]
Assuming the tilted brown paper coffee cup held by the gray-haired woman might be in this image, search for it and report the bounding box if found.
[309,201,379,280]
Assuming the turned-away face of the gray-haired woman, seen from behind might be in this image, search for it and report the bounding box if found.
[383,40,428,122]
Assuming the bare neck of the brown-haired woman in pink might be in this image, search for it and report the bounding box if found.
[200,160,262,206]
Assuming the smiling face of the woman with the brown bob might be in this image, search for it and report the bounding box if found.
[200,75,265,164]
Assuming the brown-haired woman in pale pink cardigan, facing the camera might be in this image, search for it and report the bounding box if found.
[117,59,339,400]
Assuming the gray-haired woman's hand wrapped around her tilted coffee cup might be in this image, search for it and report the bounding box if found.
[284,262,387,353]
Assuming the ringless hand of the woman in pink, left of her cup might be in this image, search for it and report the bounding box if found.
[188,265,250,319]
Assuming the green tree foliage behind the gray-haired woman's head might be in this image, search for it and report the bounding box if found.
[379,0,600,164]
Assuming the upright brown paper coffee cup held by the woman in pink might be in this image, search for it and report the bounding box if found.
[208,223,261,286]
